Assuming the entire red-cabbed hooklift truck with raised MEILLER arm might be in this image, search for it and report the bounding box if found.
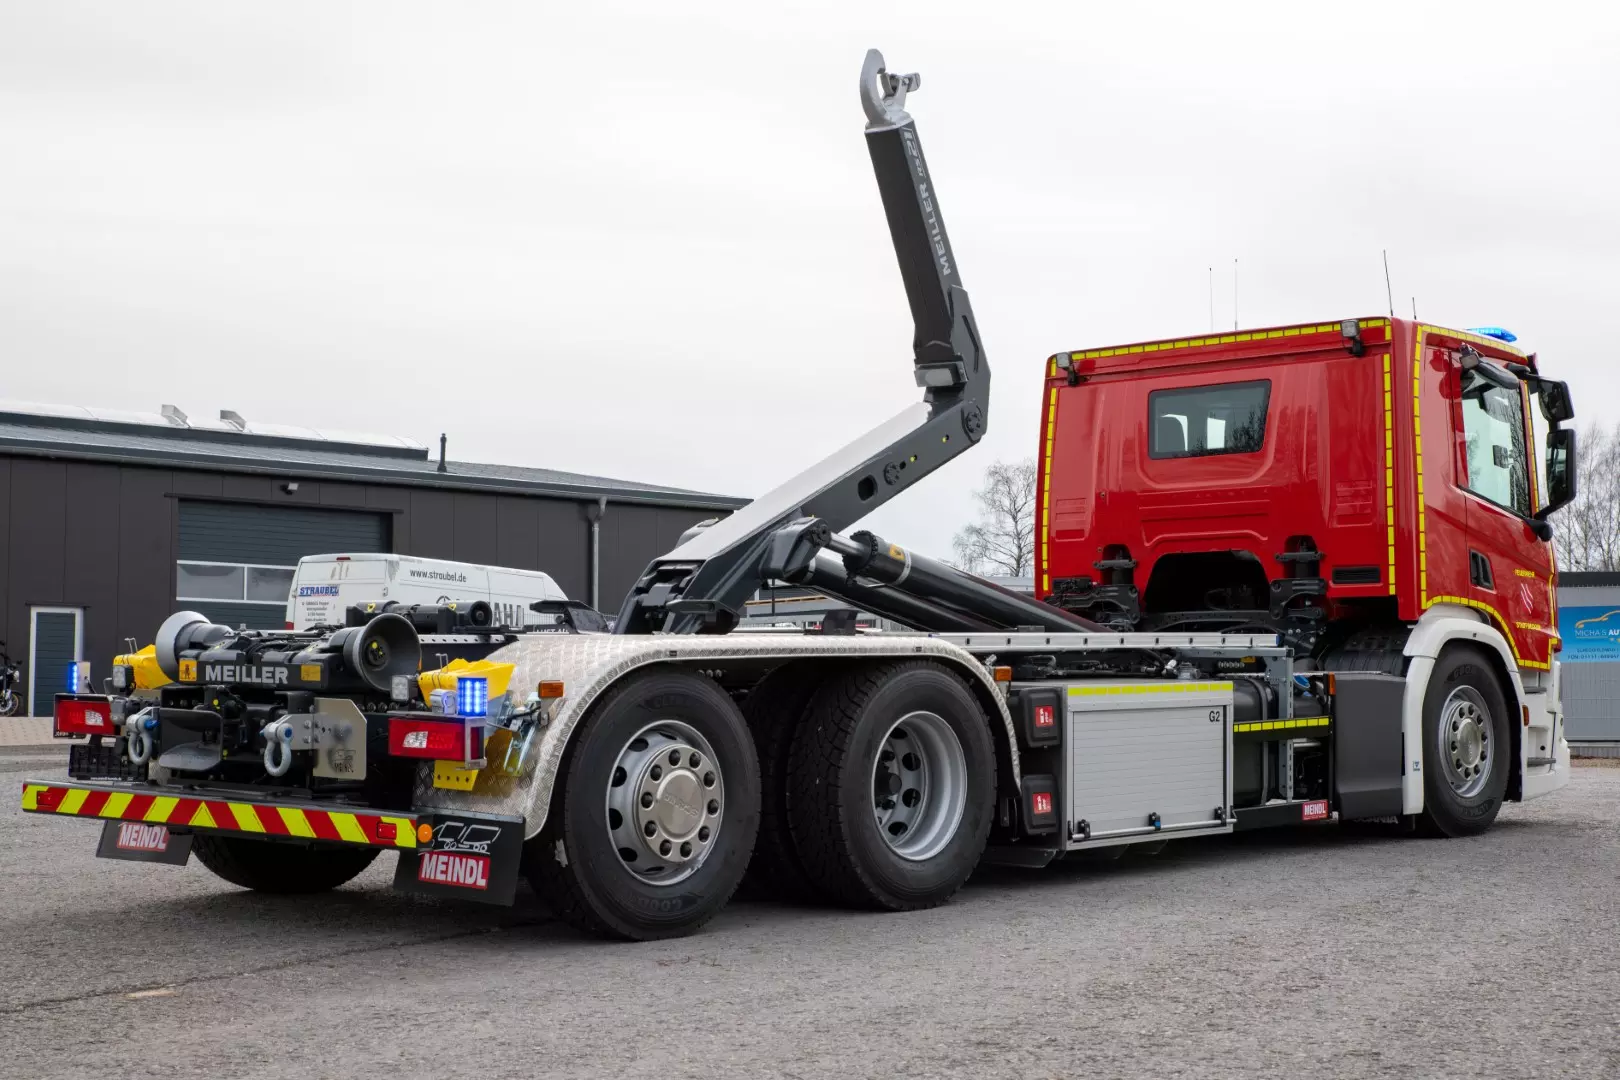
[23,52,1575,939]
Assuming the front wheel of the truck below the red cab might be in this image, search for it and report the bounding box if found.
[1421,646,1511,836]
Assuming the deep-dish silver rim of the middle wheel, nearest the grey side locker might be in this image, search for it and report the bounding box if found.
[872,711,967,863]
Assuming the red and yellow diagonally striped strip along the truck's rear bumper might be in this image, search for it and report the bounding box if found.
[23,782,416,847]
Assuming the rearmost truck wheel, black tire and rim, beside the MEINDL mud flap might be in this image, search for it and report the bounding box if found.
[523,670,760,941]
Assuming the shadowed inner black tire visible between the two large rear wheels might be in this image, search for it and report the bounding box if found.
[742,664,829,904]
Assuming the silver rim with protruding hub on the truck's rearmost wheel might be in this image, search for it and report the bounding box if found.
[606,721,726,887]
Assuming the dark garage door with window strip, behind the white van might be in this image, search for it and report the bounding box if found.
[175,499,392,628]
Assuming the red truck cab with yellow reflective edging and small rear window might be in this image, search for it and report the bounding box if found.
[1035,317,1575,670]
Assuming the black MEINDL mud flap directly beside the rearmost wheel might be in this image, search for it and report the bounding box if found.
[394,811,523,905]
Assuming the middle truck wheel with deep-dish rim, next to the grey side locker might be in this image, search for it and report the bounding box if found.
[787,661,996,912]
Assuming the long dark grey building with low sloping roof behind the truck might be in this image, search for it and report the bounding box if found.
[0,403,745,716]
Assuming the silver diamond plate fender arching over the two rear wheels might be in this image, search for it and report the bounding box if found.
[415,633,1021,837]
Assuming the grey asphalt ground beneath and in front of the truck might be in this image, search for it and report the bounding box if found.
[0,751,1620,1080]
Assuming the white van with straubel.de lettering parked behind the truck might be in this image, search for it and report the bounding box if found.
[287,552,569,630]
